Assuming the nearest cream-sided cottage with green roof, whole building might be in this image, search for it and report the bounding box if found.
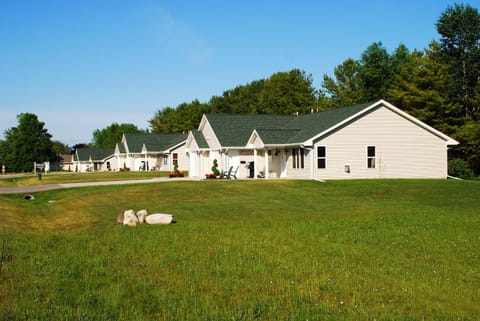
[186,100,458,180]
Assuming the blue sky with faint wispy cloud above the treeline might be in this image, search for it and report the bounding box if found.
[0,0,464,145]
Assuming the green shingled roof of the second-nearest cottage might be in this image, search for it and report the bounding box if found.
[125,133,188,153]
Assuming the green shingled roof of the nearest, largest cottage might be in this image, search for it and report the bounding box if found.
[203,102,373,147]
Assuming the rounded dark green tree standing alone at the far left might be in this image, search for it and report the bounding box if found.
[0,113,55,172]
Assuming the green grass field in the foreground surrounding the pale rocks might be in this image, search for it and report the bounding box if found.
[0,180,480,321]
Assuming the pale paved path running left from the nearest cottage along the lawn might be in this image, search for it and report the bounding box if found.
[0,177,199,194]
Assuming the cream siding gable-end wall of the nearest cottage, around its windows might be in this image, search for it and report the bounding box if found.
[314,107,447,179]
